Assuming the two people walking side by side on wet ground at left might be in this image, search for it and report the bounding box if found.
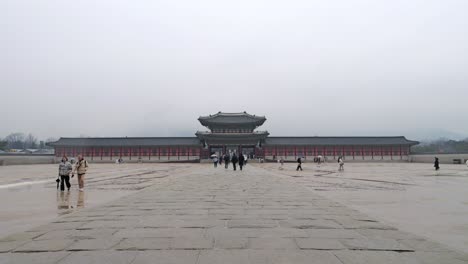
[57,155,88,192]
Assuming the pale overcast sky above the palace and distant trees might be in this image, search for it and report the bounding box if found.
[0,0,468,139]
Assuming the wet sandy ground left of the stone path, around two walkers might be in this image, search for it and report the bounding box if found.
[0,164,190,237]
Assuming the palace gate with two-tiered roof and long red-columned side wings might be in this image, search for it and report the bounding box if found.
[49,112,418,162]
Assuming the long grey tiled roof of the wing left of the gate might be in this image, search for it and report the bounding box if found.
[47,137,200,147]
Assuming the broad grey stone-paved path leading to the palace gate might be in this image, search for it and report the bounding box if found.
[0,164,468,264]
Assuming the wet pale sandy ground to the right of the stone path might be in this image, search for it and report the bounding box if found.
[264,163,468,252]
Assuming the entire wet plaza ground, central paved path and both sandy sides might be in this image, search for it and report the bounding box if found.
[0,162,468,264]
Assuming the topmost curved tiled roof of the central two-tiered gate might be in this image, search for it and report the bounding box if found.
[198,112,266,127]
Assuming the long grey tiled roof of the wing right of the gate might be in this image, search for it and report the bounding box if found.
[265,136,419,146]
